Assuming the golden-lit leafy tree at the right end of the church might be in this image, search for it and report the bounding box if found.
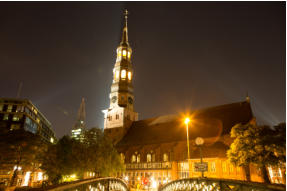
[227,122,286,183]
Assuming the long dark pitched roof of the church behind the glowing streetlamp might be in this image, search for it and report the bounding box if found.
[117,101,253,147]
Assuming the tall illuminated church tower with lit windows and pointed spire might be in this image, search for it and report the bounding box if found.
[103,10,138,144]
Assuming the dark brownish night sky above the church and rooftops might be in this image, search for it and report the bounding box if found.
[0,2,286,137]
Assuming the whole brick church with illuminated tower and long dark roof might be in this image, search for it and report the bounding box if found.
[103,10,284,185]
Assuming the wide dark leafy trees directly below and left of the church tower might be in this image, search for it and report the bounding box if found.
[41,128,123,183]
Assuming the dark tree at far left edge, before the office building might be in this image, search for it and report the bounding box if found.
[0,129,45,186]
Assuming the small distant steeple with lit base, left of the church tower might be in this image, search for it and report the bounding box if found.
[71,98,86,140]
